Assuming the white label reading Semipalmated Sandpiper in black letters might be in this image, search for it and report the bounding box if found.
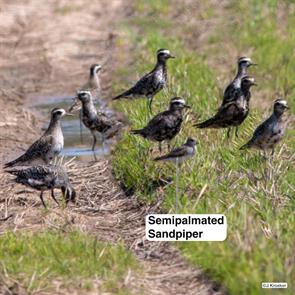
[145,214,227,241]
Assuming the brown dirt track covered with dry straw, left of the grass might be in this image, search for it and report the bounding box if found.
[0,0,224,295]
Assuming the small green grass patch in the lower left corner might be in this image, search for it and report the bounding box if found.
[0,231,137,294]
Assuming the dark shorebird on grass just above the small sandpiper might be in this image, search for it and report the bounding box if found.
[131,97,190,152]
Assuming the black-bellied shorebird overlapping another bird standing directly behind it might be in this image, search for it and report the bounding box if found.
[195,76,256,136]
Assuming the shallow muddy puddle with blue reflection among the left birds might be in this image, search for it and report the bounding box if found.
[31,95,111,161]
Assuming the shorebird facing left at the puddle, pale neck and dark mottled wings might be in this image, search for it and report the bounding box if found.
[78,91,122,151]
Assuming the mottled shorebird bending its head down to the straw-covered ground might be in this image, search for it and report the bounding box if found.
[6,165,76,208]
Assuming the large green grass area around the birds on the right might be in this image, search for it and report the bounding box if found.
[113,0,295,295]
